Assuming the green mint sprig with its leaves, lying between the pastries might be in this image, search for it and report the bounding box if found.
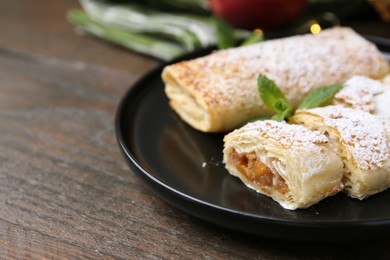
[257,74,343,121]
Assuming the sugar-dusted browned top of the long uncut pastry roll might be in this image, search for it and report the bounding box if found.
[166,27,388,111]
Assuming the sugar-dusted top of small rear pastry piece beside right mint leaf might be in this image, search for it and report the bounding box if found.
[334,76,384,112]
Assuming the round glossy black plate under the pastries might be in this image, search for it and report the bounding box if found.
[116,39,390,241]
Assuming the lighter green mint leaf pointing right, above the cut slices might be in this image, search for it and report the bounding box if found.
[298,83,343,109]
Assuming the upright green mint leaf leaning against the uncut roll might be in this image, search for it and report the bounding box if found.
[257,75,292,121]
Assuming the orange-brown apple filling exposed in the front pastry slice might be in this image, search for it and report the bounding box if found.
[230,150,289,194]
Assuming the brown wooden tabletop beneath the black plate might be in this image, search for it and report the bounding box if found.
[0,0,390,259]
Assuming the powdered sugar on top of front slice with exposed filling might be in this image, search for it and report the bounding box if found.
[233,120,328,148]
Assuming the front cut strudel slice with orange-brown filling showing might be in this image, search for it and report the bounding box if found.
[223,120,343,210]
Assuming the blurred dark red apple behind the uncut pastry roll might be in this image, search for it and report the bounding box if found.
[210,0,307,29]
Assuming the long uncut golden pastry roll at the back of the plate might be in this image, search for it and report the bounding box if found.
[162,27,389,132]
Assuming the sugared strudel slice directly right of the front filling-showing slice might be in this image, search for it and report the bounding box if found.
[291,106,390,199]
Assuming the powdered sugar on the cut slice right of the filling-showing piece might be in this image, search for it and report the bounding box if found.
[308,106,390,170]
